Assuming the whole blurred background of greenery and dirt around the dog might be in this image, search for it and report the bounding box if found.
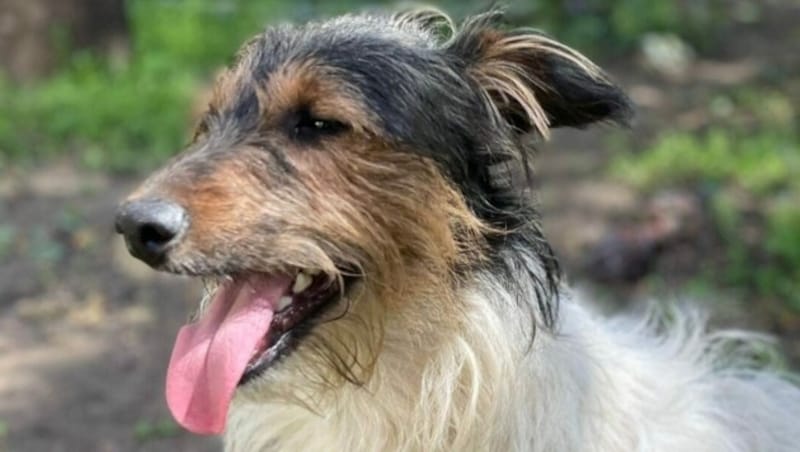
[0,0,800,452]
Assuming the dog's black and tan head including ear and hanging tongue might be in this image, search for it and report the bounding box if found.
[117,11,629,433]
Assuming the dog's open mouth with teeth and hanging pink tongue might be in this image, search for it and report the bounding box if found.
[166,270,346,434]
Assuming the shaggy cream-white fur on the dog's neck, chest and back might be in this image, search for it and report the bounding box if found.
[226,235,800,452]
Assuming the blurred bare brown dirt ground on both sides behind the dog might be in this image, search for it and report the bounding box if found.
[0,4,800,452]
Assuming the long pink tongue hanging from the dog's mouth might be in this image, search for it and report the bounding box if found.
[167,276,291,435]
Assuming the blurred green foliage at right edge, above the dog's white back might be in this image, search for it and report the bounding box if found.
[612,91,800,310]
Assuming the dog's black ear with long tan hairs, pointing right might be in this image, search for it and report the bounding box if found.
[446,11,632,138]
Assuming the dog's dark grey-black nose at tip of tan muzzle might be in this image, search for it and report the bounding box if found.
[114,199,189,265]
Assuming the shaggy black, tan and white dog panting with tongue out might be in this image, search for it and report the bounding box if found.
[116,9,800,452]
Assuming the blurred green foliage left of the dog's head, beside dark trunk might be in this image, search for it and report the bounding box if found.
[0,0,300,170]
